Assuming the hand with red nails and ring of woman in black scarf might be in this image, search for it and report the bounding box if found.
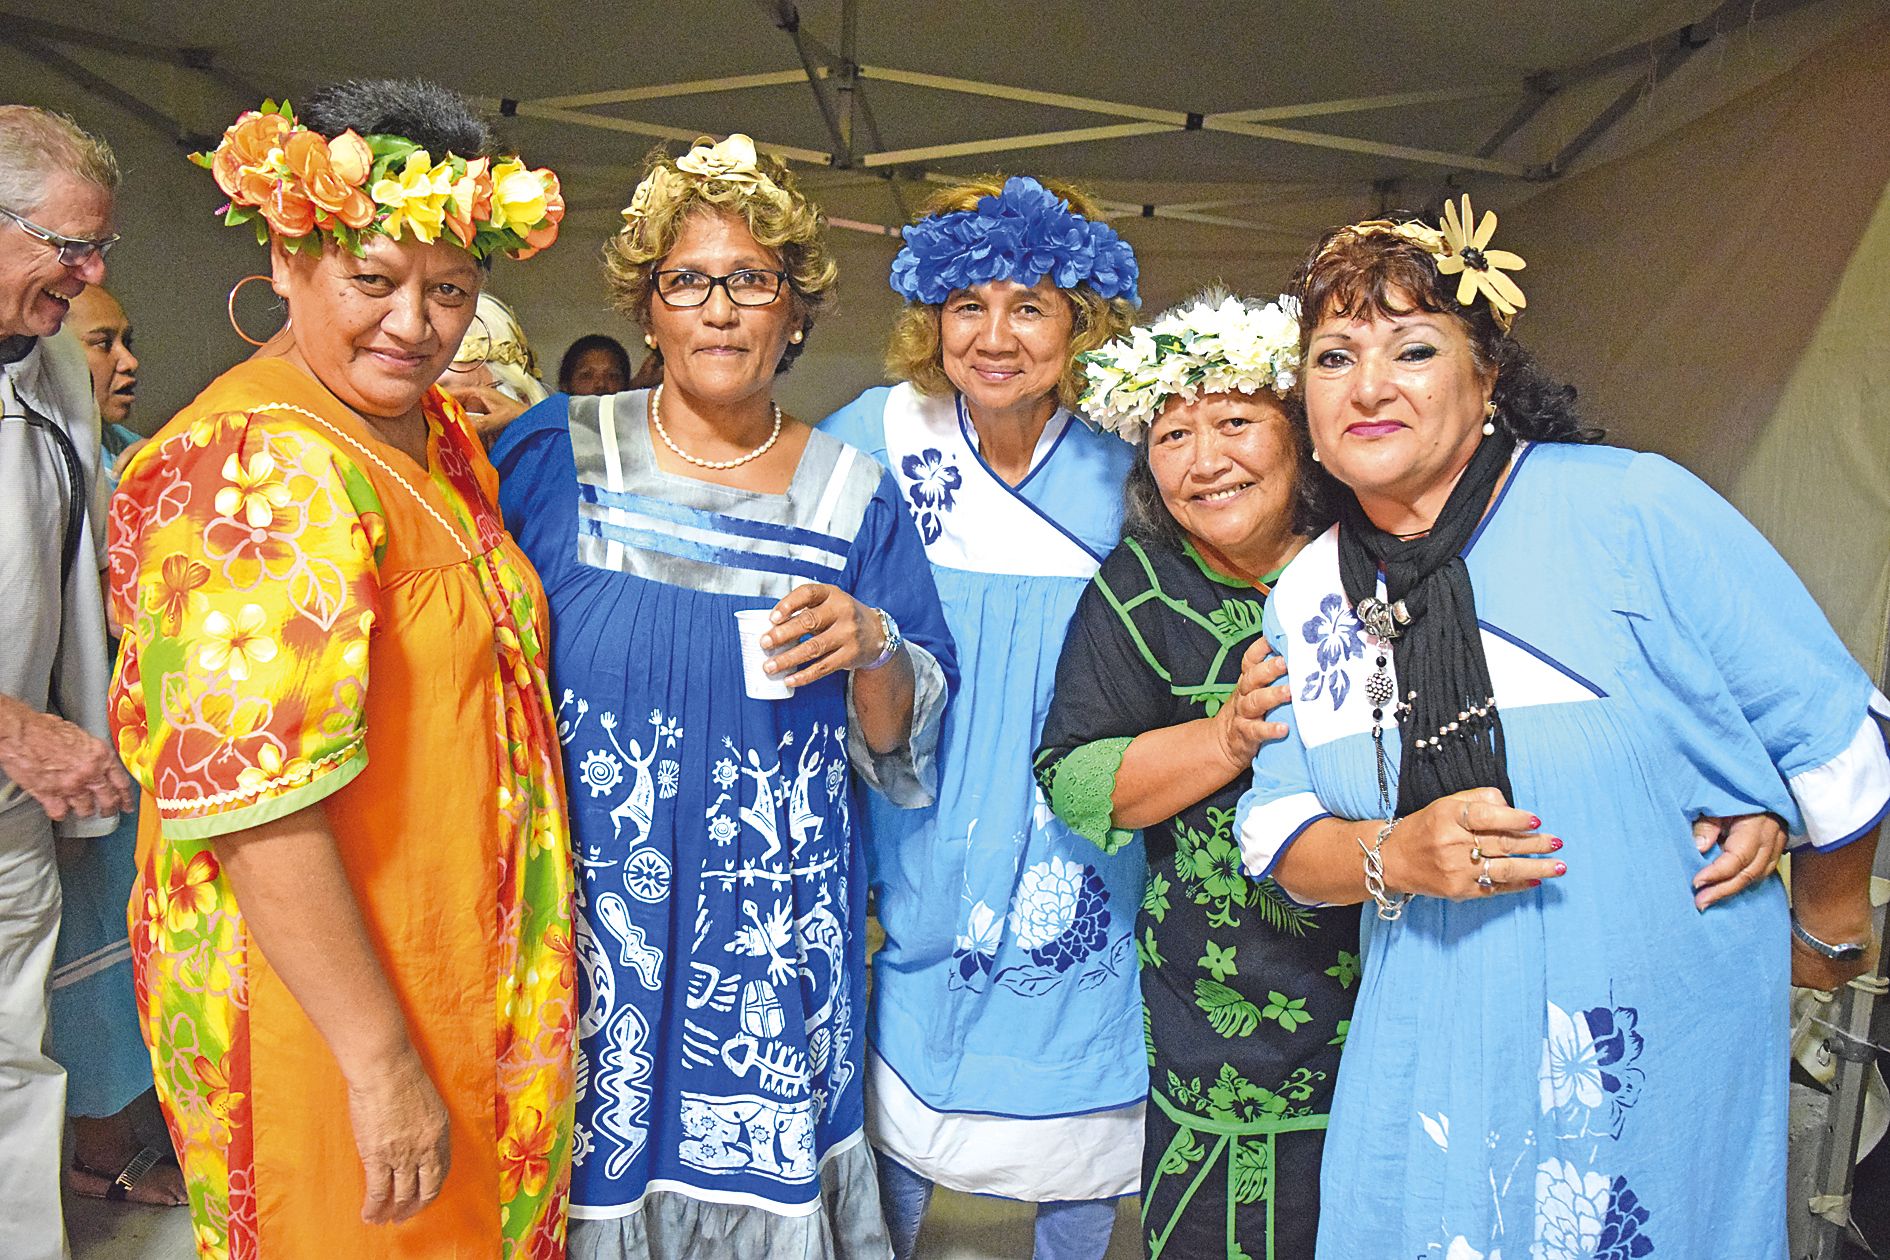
[1382,788,1569,901]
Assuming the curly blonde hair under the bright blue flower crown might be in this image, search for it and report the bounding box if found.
[886,176,1136,410]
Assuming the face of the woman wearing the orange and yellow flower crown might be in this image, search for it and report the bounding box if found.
[270,234,484,419]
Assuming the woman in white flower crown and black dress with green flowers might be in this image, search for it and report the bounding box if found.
[1038,291,1359,1260]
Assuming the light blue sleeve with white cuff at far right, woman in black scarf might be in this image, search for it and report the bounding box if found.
[1620,447,1890,848]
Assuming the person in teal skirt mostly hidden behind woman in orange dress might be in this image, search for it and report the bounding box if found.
[51,285,185,1207]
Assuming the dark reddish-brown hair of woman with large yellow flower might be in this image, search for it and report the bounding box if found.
[1289,215,1605,453]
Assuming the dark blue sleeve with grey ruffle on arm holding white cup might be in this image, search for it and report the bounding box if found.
[841,465,958,809]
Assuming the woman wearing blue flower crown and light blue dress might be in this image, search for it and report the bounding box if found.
[822,178,1147,1260]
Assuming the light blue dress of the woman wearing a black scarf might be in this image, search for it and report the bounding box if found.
[1238,444,1890,1260]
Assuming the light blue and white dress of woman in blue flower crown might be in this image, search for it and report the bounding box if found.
[822,385,1147,1201]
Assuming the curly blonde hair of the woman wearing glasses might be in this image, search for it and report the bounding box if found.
[603,136,839,372]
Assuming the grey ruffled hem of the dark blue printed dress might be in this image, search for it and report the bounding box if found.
[567,1141,892,1260]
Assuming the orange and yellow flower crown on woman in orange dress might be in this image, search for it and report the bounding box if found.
[191,100,565,259]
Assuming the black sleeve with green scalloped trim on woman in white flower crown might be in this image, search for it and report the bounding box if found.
[1036,542,1174,854]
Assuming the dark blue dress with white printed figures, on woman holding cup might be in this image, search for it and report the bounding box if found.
[493,391,956,1260]
